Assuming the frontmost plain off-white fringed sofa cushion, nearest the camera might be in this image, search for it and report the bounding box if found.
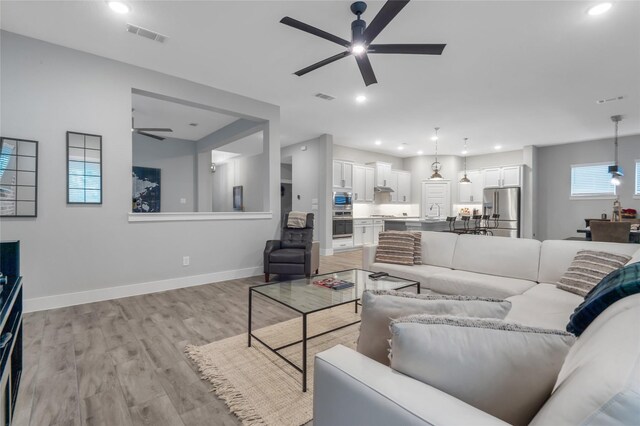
[391,315,575,425]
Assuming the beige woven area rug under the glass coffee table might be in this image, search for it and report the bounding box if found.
[185,304,360,426]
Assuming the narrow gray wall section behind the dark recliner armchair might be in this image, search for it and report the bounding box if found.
[281,135,334,254]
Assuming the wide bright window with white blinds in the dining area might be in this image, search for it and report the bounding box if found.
[571,163,616,198]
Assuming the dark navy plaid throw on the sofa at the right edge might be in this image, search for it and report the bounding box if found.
[567,262,640,336]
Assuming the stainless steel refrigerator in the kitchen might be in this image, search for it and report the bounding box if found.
[482,187,520,238]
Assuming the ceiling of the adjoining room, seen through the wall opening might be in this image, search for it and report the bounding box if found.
[131,94,238,141]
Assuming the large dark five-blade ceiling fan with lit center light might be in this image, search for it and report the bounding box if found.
[280,0,446,86]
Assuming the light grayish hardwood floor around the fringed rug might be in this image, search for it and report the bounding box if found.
[14,250,362,426]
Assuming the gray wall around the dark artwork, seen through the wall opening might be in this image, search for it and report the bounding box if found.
[132,133,197,212]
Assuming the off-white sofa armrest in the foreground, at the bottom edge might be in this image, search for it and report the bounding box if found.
[313,345,507,426]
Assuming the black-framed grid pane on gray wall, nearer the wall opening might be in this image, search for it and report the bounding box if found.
[67,132,102,204]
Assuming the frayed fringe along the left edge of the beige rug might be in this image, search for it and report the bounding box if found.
[184,345,267,426]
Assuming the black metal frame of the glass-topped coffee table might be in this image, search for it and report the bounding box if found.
[247,268,420,392]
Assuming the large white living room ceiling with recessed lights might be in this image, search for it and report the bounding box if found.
[0,0,640,157]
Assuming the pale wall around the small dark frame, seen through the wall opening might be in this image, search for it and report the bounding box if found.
[210,154,266,212]
